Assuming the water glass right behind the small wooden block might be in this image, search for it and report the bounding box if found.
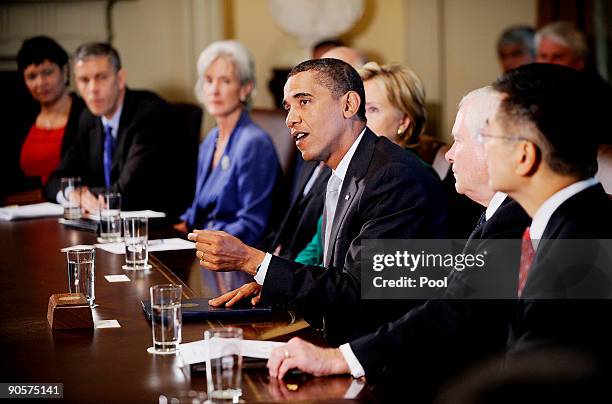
[66,247,96,307]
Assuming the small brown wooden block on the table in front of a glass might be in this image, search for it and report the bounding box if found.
[47,293,93,330]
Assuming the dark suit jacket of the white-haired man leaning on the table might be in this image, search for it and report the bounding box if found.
[350,198,531,398]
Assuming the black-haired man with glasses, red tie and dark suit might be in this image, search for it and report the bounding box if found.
[482,64,612,372]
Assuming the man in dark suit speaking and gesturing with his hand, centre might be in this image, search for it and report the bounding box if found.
[189,59,446,344]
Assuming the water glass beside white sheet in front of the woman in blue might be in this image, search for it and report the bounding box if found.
[123,217,151,269]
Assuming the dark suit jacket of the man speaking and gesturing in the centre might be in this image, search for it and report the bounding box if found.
[262,129,446,344]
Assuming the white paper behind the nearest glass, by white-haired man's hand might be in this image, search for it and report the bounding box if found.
[179,339,285,366]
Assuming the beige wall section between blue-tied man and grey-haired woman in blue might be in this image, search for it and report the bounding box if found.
[113,0,223,102]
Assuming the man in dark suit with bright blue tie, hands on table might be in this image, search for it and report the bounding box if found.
[45,43,184,215]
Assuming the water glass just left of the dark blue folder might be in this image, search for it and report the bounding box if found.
[150,284,182,354]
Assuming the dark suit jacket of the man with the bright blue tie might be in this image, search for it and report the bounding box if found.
[45,89,185,216]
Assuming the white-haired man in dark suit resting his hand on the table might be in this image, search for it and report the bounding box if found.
[268,87,529,402]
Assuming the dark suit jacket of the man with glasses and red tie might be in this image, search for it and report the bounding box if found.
[508,184,612,371]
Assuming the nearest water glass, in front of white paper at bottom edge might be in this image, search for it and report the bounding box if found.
[204,327,242,403]
